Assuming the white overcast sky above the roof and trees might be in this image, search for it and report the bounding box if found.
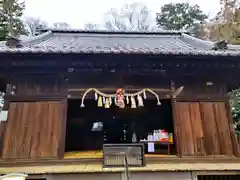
[24,0,220,28]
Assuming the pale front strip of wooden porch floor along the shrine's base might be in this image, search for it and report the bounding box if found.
[0,163,240,174]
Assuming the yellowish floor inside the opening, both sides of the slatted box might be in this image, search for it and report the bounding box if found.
[64,151,172,159]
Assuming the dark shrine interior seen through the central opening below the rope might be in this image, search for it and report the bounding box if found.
[65,99,175,154]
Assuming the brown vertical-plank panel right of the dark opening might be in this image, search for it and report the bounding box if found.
[173,102,240,156]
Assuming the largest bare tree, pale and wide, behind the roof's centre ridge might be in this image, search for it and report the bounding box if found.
[105,3,155,31]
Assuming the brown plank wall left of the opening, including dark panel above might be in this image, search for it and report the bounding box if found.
[0,75,67,159]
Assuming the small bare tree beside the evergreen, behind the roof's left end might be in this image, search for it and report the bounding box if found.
[24,17,48,36]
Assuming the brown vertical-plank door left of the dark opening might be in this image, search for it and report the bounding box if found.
[2,101,66,159]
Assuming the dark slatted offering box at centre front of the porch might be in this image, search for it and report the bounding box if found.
[103,144,145,167]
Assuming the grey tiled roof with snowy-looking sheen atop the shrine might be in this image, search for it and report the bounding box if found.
[0,30,240,56]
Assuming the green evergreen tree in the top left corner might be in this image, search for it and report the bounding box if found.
[0,0,25,40]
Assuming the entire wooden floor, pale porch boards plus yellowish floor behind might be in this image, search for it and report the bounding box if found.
[0,151,240,174]
